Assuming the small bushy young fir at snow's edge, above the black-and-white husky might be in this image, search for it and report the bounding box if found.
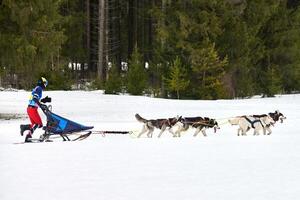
[165,57,190,99]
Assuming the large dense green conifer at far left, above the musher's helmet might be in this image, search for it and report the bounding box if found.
[0,0,66,88]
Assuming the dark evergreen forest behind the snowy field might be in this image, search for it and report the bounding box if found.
[0,0,300,99]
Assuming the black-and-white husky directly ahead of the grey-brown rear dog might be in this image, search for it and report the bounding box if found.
[175,117,220,137]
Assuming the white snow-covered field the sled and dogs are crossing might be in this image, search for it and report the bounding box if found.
[0,91,300,200]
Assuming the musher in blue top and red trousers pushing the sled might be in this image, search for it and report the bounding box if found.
[20,77,51,142]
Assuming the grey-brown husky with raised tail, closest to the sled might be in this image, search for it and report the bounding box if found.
[135,114,181,138]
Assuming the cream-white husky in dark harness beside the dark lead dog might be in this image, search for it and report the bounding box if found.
[228,115,275,136]
